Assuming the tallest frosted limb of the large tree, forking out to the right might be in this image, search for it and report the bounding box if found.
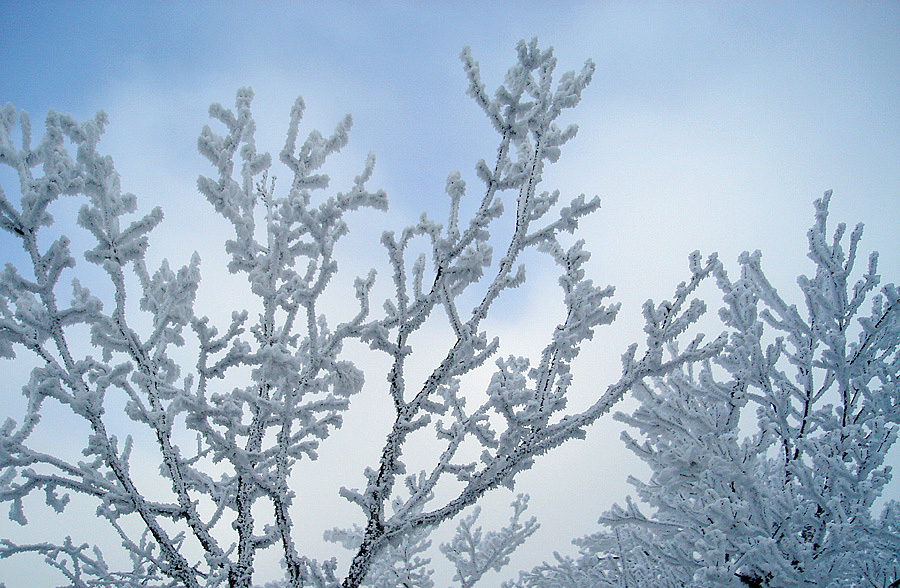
[343,41,724,588]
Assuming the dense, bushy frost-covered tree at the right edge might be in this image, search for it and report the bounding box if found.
[521,192,900,588]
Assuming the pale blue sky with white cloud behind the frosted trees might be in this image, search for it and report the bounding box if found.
[0,0,900,588]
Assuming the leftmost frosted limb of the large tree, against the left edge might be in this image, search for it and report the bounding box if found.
[0,107,206,586]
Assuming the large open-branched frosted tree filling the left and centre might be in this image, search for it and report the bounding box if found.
[0,42,724,588]
